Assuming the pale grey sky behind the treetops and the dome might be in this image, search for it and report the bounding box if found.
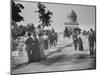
[15,1,95,32]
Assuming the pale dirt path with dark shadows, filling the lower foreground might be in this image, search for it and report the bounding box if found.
[12,37,95,74]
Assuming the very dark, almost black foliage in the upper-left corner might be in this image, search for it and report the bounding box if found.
[11,0,24,22]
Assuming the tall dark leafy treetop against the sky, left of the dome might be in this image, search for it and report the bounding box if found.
[36,2,52,27]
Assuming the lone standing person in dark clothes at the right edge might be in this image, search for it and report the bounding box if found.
[88,28,96,55]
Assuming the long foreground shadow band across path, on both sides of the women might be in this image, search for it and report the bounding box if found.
[12,54,96,71]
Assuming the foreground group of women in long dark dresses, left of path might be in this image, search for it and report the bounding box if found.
[25,33,46,63]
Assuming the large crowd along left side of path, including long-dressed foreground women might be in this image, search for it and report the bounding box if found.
[12,29,57,63]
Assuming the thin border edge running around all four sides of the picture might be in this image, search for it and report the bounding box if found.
[10,0,97,75]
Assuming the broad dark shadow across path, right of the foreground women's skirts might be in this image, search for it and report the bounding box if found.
[40,54,96,67]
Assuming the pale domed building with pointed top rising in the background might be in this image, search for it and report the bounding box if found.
[64,9,79,32]
